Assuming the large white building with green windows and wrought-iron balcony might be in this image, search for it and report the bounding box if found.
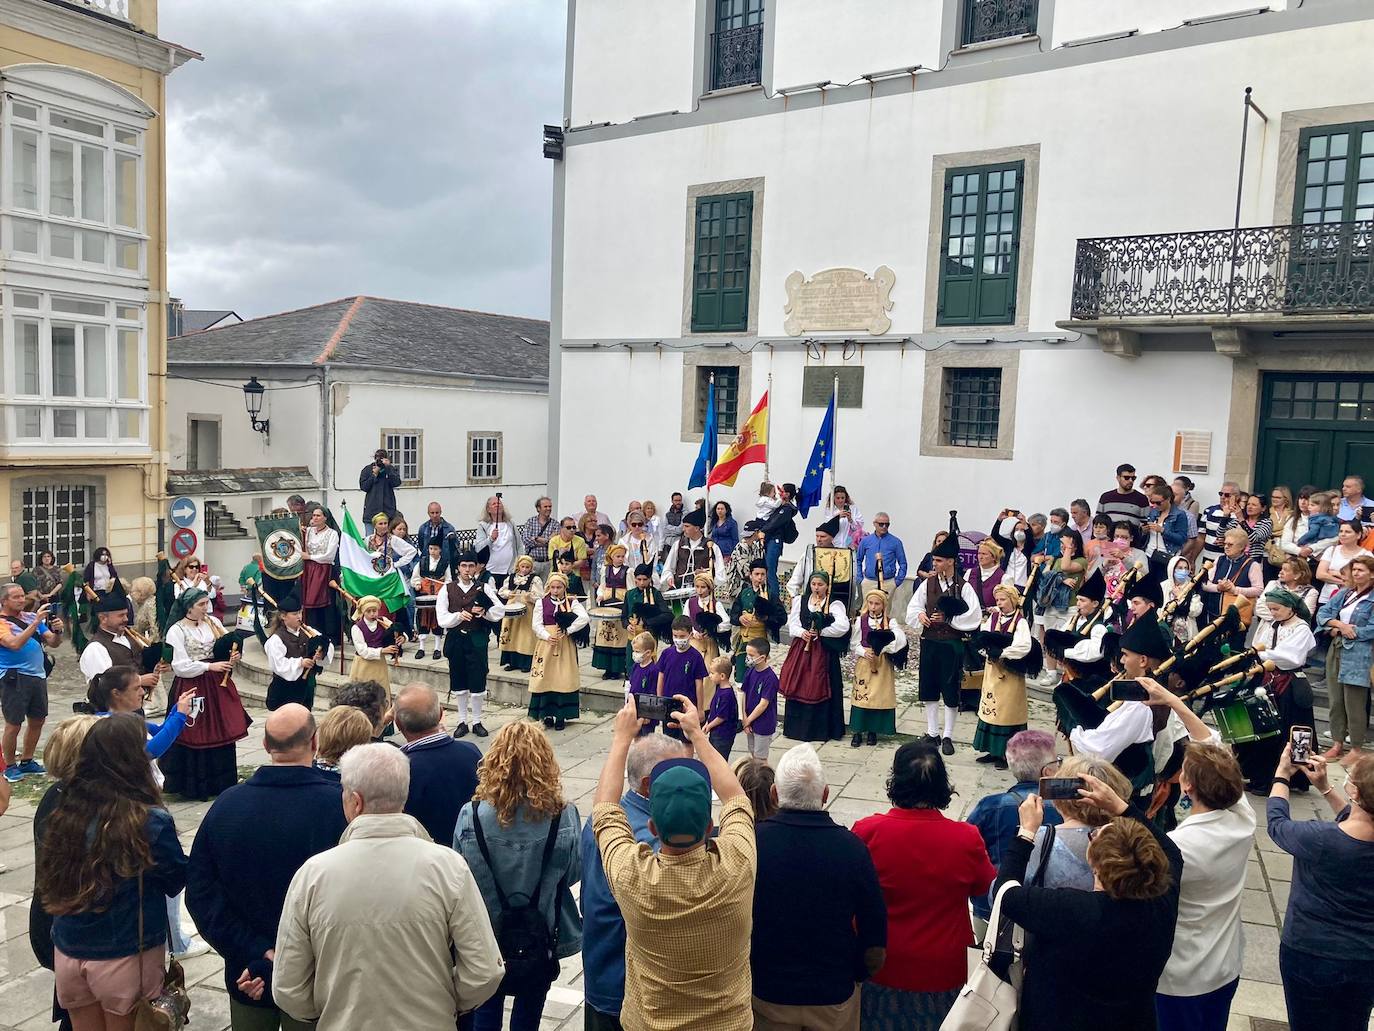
[550,0,1374,549]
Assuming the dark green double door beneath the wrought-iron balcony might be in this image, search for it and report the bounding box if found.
[1254,373,1374,495]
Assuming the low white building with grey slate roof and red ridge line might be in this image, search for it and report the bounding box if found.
[168,297,548,576]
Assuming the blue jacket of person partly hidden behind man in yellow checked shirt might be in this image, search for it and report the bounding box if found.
[581,792,658,1016]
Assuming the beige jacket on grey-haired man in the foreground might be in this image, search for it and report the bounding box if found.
[272,812,504,1031]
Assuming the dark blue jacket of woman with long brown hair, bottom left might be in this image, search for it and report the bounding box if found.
[50,810,188,960]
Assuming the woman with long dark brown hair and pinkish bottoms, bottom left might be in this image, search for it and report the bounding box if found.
[34,715,187,1030]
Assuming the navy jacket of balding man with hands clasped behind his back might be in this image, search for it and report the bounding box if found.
[185,766,348,1008]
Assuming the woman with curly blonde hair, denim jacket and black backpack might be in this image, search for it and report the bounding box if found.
[453,720,583,1031]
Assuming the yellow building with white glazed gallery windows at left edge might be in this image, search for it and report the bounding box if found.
[0,0,199,575]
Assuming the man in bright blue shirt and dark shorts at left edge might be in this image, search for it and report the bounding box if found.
[0,583,62,784]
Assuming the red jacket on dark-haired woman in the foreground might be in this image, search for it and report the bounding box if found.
[855,808,998,991]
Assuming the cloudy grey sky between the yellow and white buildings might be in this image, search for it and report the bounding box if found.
[159,0,566,318]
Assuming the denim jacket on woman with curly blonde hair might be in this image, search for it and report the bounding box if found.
[453,801,583,960]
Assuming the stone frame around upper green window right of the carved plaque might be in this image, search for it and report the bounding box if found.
[922,143,1040,340]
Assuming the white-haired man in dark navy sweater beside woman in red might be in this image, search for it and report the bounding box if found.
[749,745,888,1031]
